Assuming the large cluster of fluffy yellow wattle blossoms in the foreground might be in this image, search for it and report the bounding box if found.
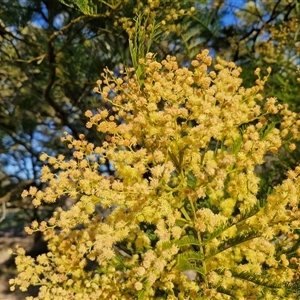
[10,50,300,300]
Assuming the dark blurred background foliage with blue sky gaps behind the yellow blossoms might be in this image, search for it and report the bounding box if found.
[0,0,300,276]
